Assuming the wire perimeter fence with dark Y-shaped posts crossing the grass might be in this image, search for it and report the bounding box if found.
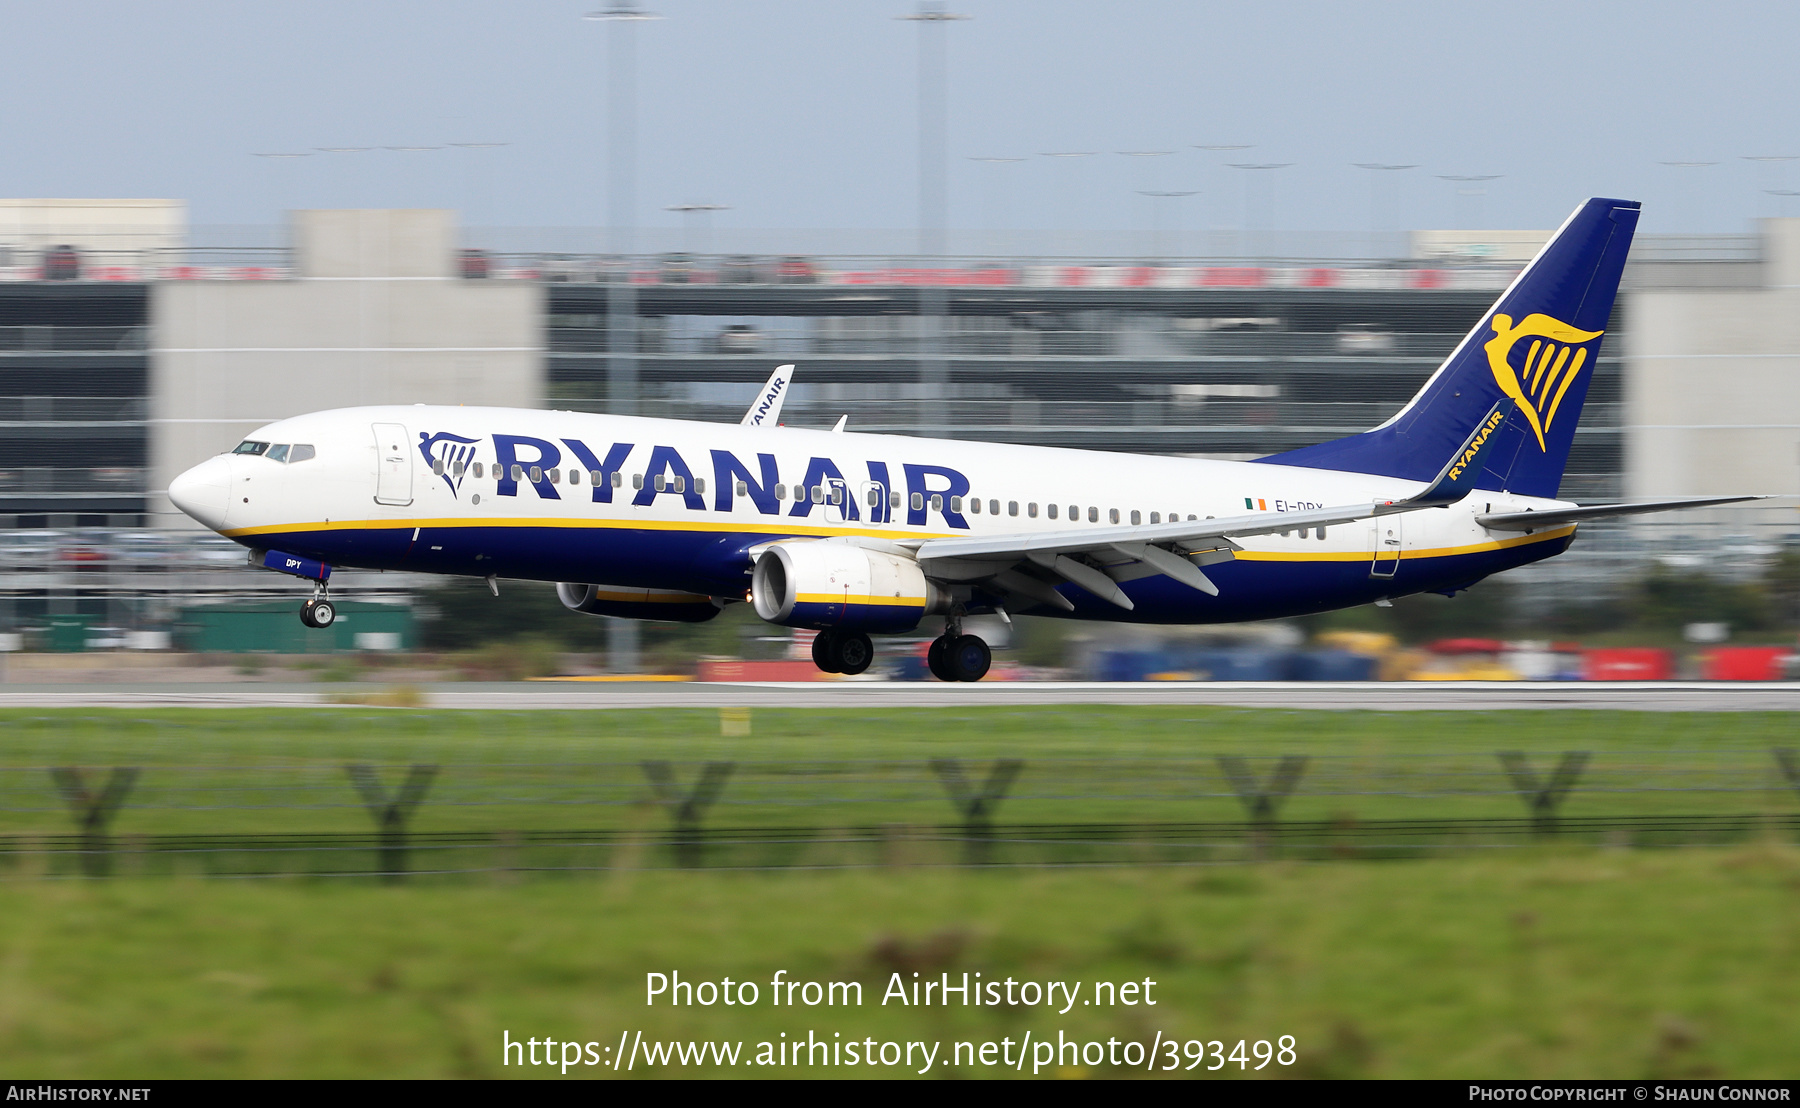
[0,746,1800,880]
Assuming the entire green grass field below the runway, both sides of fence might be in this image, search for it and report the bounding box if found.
[0,709,1800,1079]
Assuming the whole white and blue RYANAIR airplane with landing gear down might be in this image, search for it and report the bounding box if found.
[169,200,1750,682]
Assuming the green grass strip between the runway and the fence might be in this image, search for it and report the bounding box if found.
[0,707,1796,835]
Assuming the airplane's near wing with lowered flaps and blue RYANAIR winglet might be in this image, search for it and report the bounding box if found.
[916,401,1510,612]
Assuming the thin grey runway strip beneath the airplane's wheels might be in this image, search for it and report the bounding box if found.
[0,682,1800,712]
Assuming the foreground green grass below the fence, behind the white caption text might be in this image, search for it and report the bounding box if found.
[0,844,1800,1077]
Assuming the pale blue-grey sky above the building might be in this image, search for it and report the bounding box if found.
[0,0,1800,232]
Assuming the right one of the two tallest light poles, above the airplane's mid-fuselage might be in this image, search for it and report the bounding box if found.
[895,0,968,435]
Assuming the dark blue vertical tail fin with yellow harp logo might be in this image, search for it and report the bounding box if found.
[1262,198,1638,496]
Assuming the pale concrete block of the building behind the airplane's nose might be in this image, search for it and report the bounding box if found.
[148,210,545,527]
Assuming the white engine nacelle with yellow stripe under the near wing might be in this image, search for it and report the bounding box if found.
[751,540,950,633]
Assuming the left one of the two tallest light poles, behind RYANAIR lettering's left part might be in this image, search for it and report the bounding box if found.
[585,0,659,673]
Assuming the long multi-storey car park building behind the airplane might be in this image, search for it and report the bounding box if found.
[0,201,1800,633]
